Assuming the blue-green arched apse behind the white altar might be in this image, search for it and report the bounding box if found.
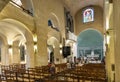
[77,28,103,60]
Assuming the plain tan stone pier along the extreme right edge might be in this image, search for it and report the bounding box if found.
[113,0,120,82]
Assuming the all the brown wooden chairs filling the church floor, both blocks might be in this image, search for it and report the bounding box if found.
[0,63,107,82]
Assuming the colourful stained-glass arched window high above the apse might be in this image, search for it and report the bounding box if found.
[83,8,94,23]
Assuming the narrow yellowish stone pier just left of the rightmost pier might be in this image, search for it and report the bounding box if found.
[107,3,115,82]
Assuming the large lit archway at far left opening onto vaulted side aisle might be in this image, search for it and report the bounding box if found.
[0,19,33,66]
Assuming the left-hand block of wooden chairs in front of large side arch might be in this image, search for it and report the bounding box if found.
[1,65,67,82]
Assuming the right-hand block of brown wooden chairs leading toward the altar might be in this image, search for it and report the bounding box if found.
[48,64,107,82]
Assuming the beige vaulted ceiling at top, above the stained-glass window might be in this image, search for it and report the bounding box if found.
[62,0,105,15]
